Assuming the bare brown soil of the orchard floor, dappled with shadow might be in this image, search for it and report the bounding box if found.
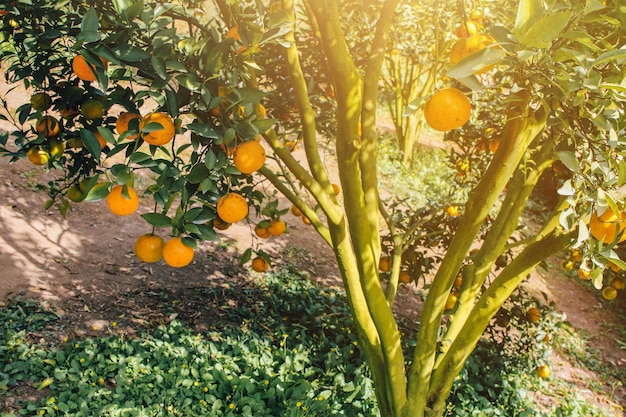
[0,148,626,415]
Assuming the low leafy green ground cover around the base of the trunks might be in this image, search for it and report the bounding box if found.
[0,270,616,417]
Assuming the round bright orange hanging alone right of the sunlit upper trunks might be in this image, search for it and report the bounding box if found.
[424,87,472,131]
